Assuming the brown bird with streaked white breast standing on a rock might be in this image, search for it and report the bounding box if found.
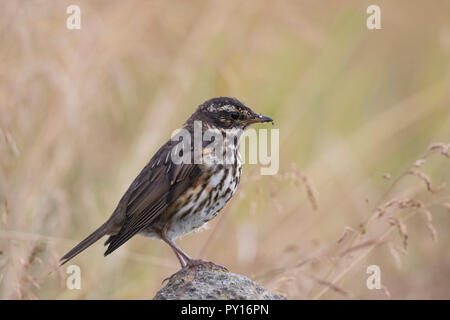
[60,97,274,268]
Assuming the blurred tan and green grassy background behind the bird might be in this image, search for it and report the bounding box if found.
[0,0,450,299]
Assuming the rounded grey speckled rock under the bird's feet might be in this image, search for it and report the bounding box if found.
[153,264,286,300]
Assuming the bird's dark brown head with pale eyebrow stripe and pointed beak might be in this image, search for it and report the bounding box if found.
[190,97,273,130]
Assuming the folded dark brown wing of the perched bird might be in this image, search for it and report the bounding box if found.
[105,141,202,256]
